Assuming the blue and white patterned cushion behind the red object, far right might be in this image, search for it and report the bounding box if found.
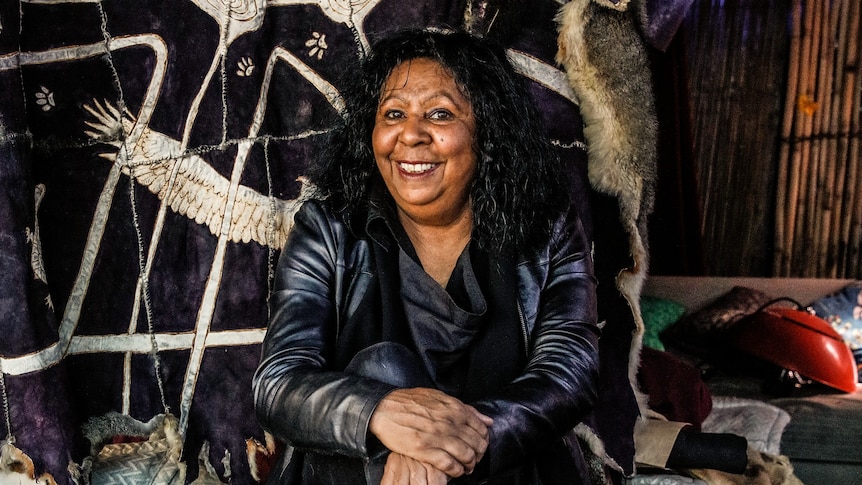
[809,281,862,381]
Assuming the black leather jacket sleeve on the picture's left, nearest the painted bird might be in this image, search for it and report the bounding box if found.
[252,202,392,456]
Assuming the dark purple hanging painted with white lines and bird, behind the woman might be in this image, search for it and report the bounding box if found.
[0,0,648,484]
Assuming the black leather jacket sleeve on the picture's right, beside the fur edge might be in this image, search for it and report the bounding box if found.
[472,204,600,478]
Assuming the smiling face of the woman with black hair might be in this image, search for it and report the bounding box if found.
[371,58,476,225]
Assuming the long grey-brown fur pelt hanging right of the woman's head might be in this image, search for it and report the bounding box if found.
[557,0,658,356]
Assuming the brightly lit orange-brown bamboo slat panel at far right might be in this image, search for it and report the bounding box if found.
[774,0,862,279]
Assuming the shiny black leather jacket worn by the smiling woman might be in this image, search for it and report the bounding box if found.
[253,201,599,482]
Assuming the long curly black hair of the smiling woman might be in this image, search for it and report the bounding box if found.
[309,29,571,253]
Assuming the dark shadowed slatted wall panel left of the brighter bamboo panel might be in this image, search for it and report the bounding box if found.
[684,0,792,276]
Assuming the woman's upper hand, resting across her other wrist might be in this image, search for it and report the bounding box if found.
[369,387,493,476]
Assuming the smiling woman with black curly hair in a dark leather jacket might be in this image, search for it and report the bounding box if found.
[254,30,598,485]
